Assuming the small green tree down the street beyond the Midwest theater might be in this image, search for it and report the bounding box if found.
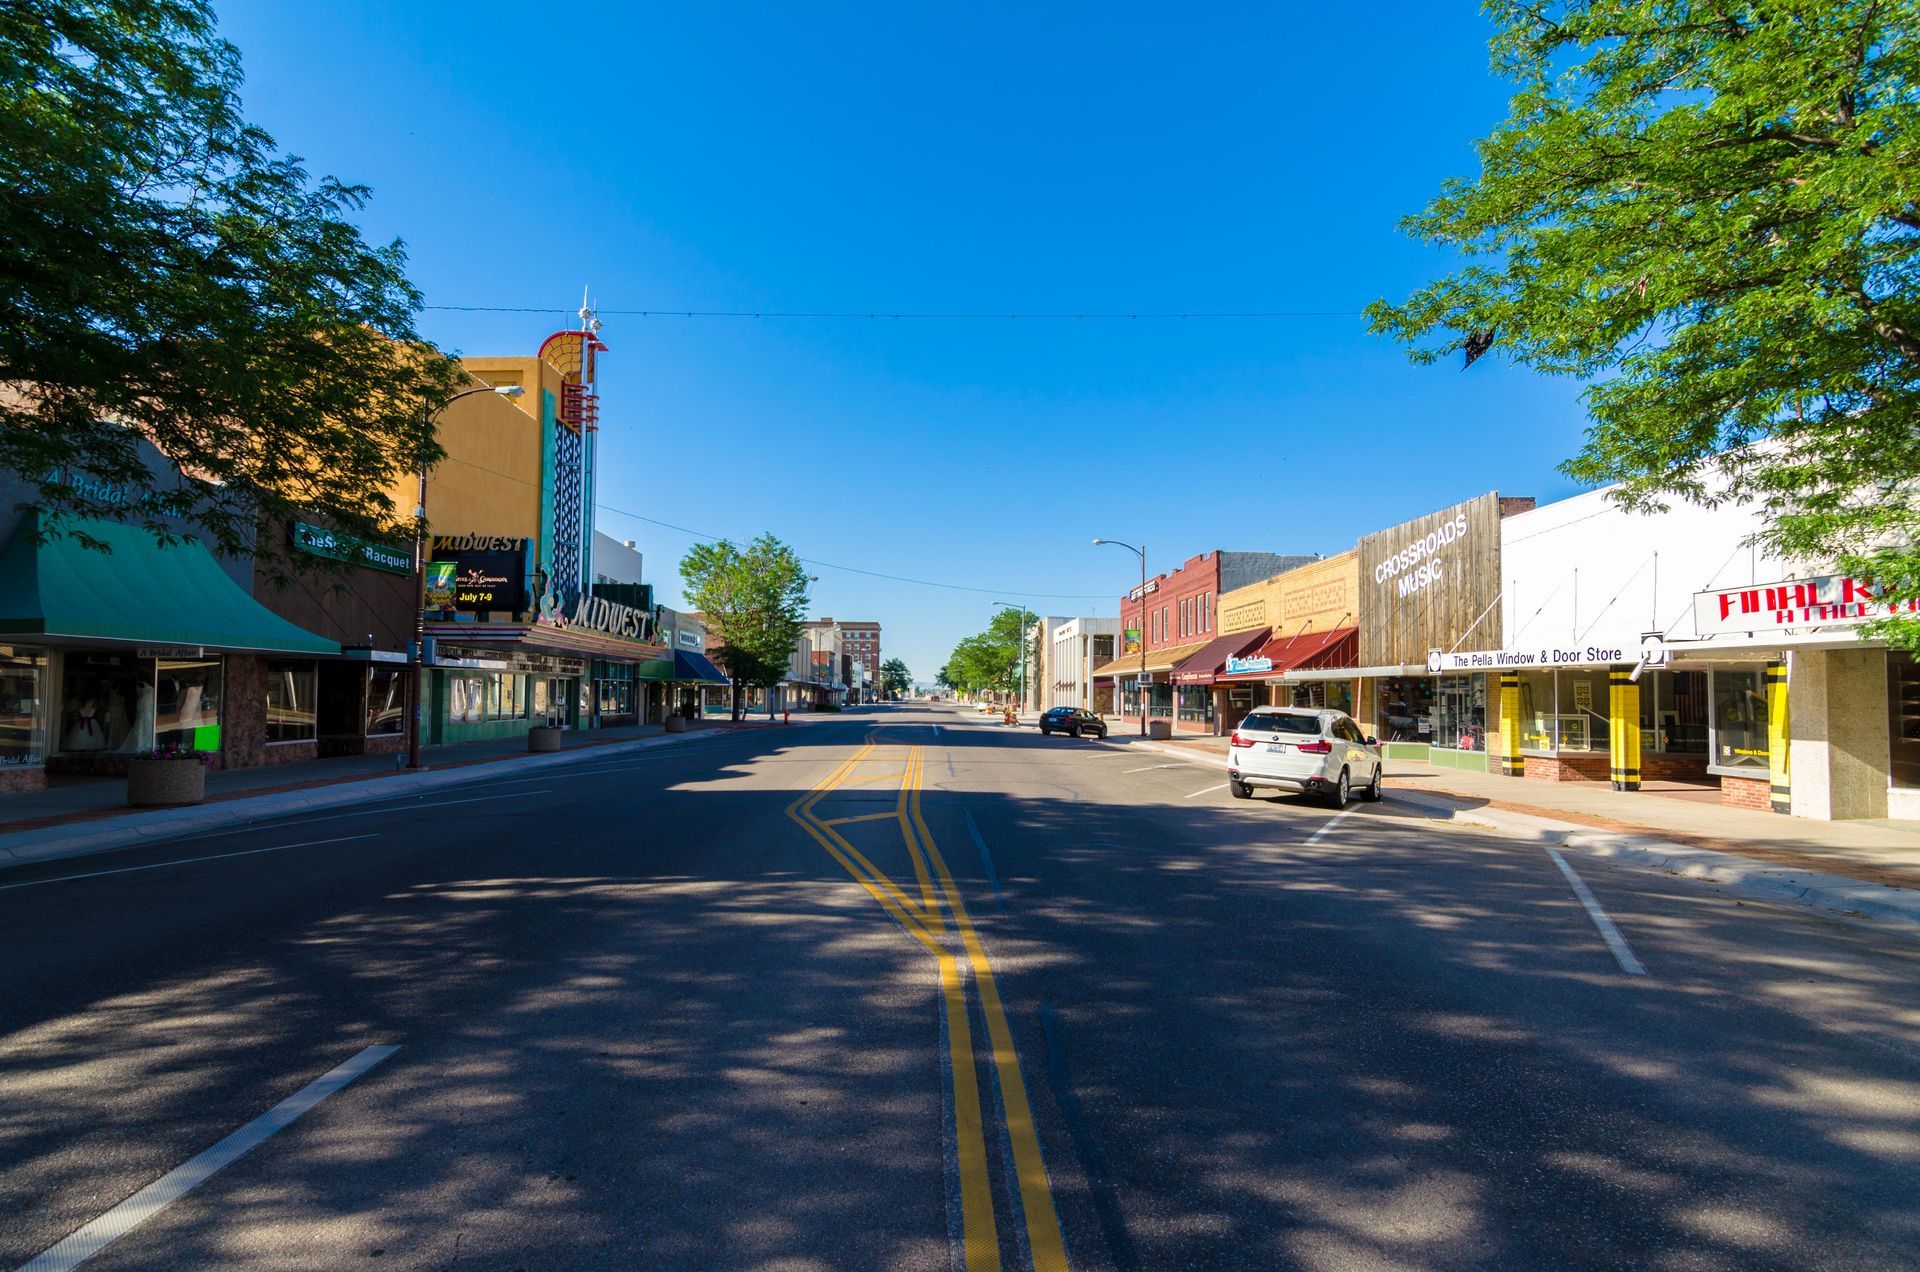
[680,534,814,721]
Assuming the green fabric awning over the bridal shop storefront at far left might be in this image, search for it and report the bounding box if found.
[0,513,340,653]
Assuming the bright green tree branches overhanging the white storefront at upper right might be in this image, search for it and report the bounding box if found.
[1369,0,1920,644]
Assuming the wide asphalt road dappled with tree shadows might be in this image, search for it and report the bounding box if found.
[0,707,1920,1272]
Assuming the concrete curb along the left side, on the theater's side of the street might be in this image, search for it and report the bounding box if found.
[0,728,735,870]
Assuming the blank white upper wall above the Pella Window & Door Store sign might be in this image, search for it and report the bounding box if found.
[1497,488,1788,649]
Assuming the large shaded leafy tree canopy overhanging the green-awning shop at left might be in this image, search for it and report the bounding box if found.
[0,0,459,557]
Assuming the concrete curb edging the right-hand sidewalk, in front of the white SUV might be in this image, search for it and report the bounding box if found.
[1386,788,1920,936]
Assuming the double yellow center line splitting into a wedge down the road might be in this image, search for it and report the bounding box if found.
[787,742,1068,1272]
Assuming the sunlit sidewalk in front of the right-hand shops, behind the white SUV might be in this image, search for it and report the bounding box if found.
[1116,734,1920,922]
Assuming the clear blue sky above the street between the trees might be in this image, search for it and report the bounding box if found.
[219,0,1584,678]
